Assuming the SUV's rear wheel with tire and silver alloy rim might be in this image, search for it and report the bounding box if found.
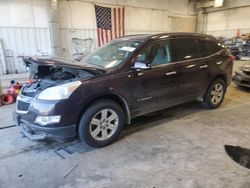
[202,78,227,109]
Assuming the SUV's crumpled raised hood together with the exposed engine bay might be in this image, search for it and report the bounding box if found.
[20,57,101,97]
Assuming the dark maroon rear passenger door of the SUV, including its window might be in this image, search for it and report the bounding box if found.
[171,37,211,103]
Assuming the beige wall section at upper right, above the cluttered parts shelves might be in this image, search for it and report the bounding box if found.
[207,0,250,38]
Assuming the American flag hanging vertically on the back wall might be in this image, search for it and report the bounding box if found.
[95,5,125,47]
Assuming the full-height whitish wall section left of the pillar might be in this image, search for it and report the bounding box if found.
[0,0,51,73]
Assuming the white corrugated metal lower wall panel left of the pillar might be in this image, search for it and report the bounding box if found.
[0,27,51,73]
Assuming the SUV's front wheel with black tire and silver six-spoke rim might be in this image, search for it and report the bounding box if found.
[78,99,124,147]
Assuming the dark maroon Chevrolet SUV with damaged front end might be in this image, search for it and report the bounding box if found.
[15,33,232,147]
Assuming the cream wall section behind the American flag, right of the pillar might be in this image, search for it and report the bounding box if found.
[59,0,195,57]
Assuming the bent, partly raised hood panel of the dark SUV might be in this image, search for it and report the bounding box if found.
[23,56,105,72]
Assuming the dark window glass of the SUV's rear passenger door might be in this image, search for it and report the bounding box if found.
[170,38,201,61]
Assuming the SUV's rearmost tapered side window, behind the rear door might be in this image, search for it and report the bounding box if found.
[199,40,223,57]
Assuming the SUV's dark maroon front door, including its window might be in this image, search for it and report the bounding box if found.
[128,41,180,116]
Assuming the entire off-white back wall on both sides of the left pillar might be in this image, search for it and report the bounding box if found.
[0,0,195,73]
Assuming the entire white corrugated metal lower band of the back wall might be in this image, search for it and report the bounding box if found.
[0,27,164,73]
